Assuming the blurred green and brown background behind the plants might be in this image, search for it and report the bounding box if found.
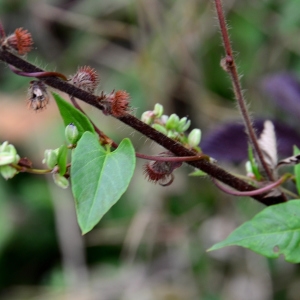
[0,0,300,300]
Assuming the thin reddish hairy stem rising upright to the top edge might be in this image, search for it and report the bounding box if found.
[215,0,275,181]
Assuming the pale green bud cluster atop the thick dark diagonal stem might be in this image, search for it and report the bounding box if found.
[141,103,201,150]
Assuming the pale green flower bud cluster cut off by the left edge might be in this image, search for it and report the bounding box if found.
[0,141,20,179]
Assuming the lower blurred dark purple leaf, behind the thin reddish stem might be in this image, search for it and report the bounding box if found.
[200,120,300,163]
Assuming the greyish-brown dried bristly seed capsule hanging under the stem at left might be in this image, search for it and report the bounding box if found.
[27,80,49,111]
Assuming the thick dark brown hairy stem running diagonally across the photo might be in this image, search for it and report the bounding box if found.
[0,49,284,205]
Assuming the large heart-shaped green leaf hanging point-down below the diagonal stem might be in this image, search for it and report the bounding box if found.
[71,132,135,234]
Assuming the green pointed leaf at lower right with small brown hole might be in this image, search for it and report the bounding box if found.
[208,199,300,263]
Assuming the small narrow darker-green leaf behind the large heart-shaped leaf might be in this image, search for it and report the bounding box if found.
[52,93,95,137]
